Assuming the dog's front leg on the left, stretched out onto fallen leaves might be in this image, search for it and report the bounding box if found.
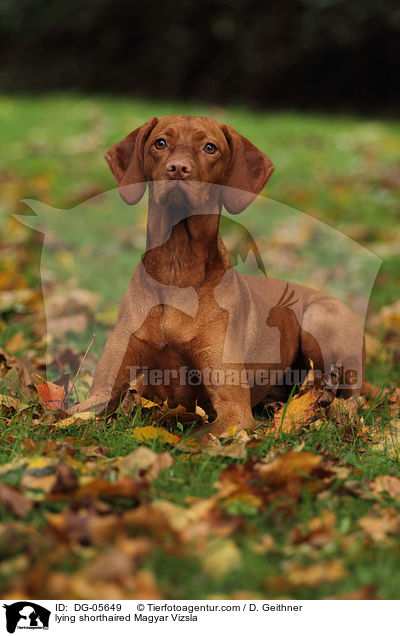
[69,321,143,415]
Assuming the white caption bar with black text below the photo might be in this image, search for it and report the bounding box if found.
[0,600,400,636]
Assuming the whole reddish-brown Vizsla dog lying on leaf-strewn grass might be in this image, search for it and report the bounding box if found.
[74,116,363,435]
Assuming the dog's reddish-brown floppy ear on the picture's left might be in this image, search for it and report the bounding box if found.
[104,117,158,205]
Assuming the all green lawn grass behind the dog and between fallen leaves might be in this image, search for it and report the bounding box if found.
[0,95,400,598]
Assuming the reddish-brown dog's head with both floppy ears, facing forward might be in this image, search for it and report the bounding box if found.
[105,115,274,214]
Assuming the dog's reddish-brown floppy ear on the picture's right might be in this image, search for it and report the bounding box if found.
[222,126,274,214]
